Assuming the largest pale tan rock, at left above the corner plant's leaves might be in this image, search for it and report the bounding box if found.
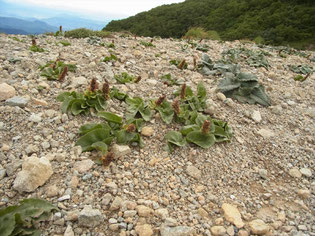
[13,156,53,193]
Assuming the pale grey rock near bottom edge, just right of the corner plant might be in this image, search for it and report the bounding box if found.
[78,206,104,228]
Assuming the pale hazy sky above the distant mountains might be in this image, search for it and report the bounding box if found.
[0,0,184,19]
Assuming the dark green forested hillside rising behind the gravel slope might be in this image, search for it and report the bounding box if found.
[104,0,315,46]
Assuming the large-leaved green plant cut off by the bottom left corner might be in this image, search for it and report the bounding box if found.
[0,198,58,236]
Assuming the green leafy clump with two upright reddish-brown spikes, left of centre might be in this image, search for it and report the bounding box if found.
[57,79,110,116]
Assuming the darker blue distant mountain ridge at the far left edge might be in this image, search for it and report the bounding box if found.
[0,17,58,34]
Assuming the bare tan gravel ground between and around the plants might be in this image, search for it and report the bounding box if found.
[0,34,315,236]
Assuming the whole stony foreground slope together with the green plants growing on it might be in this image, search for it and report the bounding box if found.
[0,33,315,236]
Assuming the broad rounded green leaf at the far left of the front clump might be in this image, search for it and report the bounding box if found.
[75,128,110,152]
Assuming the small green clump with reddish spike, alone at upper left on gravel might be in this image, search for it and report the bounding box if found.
[39,58,76,82]
